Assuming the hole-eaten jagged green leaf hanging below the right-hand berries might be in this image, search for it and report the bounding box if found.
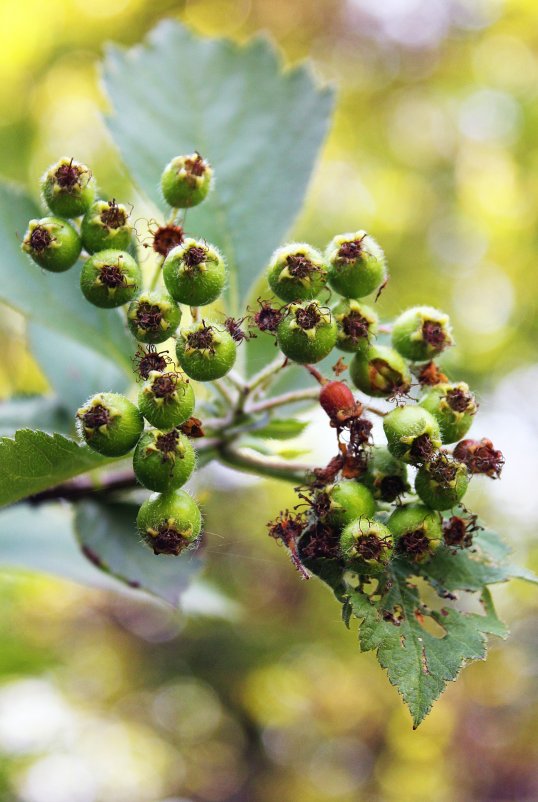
[349,560,507,727]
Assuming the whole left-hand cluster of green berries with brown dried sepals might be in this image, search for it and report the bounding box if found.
[22,154,232,554]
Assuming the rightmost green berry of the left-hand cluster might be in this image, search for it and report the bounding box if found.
[176,321,236,382]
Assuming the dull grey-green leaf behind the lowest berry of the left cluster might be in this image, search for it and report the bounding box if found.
[75,501,202,607]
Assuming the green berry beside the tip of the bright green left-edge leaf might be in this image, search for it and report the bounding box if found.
[77,393,144,457]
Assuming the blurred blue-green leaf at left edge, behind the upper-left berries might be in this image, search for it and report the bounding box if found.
[0,183,132,375]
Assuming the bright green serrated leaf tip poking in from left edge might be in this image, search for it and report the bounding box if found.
[0,429,112,507]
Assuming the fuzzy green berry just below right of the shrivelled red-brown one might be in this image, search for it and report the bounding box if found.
[163,239,226,306]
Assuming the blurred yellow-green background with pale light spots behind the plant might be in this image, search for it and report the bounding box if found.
[0,0,538,802]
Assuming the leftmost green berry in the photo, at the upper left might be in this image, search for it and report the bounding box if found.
[21,217,82,273]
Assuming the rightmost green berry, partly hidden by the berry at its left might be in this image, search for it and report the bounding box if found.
[420,382,478,443]
